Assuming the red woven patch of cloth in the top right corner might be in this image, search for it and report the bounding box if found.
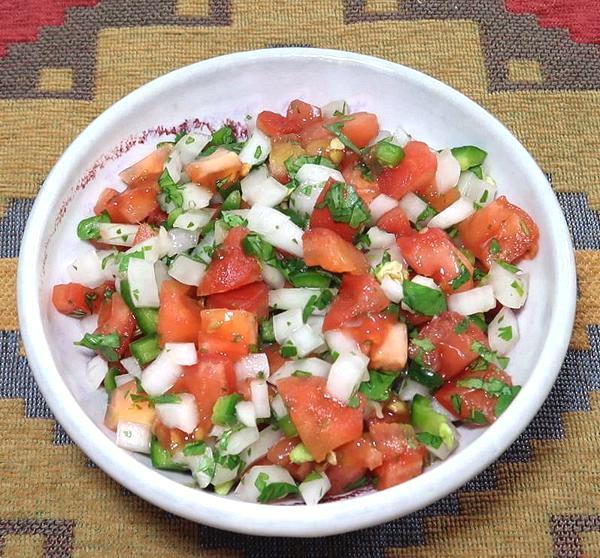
[505,0,600,44]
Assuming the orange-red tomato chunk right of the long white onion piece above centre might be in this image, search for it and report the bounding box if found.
[302,228,369,275]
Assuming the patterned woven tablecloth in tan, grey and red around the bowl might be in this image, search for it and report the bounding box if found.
[0,0,600,558]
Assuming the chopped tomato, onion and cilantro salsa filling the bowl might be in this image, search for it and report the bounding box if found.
[52,100,539,504]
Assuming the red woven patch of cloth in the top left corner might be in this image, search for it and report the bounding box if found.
[0,0,99,56]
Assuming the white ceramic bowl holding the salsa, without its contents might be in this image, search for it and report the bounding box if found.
[18,48,576,537]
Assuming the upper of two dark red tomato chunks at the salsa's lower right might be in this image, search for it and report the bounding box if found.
[409,312,487,380]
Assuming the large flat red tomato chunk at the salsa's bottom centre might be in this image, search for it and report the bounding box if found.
[278,376,364,462]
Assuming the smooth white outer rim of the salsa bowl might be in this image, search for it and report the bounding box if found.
[17,48,576,537]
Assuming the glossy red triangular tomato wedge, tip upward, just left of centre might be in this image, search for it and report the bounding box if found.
[198,227,262,296]
